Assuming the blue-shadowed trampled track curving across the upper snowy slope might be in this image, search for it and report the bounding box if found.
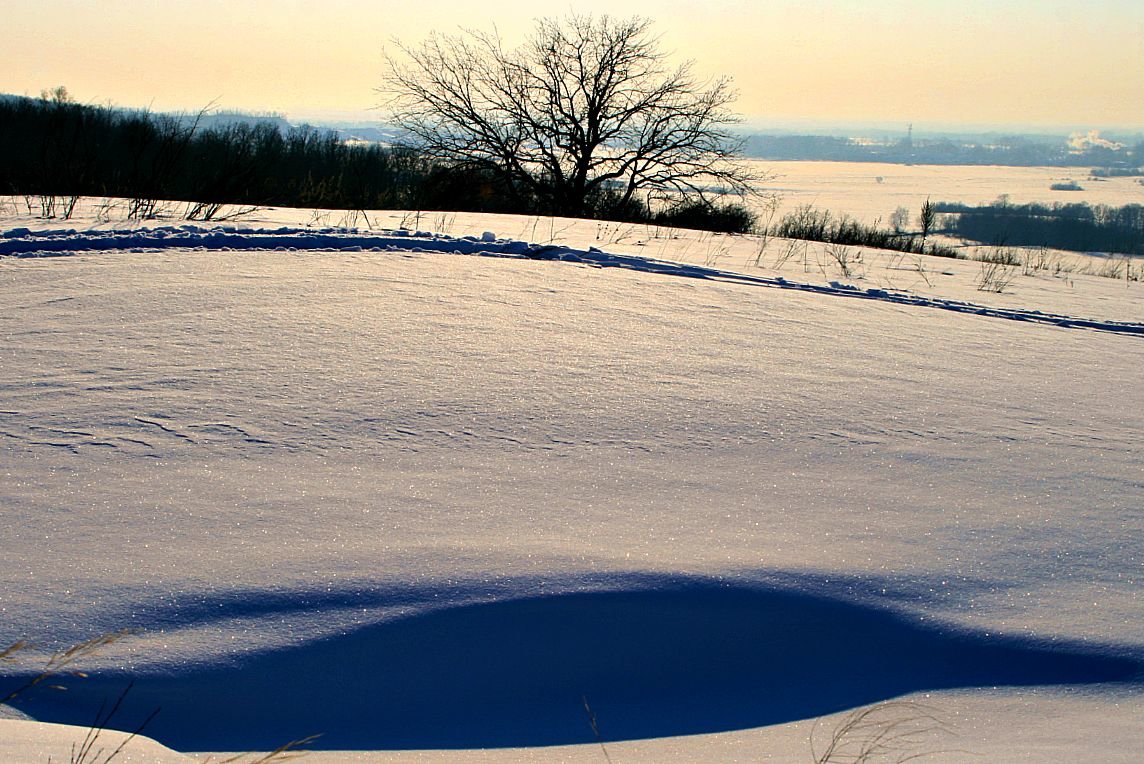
[0,225,1144,335]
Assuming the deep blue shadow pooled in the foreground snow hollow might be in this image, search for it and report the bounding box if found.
[4,582,1144,750]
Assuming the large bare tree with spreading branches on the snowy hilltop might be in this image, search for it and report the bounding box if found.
[379,15,757,215]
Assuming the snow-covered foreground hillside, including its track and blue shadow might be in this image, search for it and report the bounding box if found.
[0,204,1144,764]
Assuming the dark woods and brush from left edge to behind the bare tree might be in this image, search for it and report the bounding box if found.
[0,88,755,232]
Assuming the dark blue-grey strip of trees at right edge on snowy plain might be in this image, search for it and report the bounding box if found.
[935,201,1144,255]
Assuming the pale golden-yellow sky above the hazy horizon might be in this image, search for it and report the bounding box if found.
[8,0,1144,129]
